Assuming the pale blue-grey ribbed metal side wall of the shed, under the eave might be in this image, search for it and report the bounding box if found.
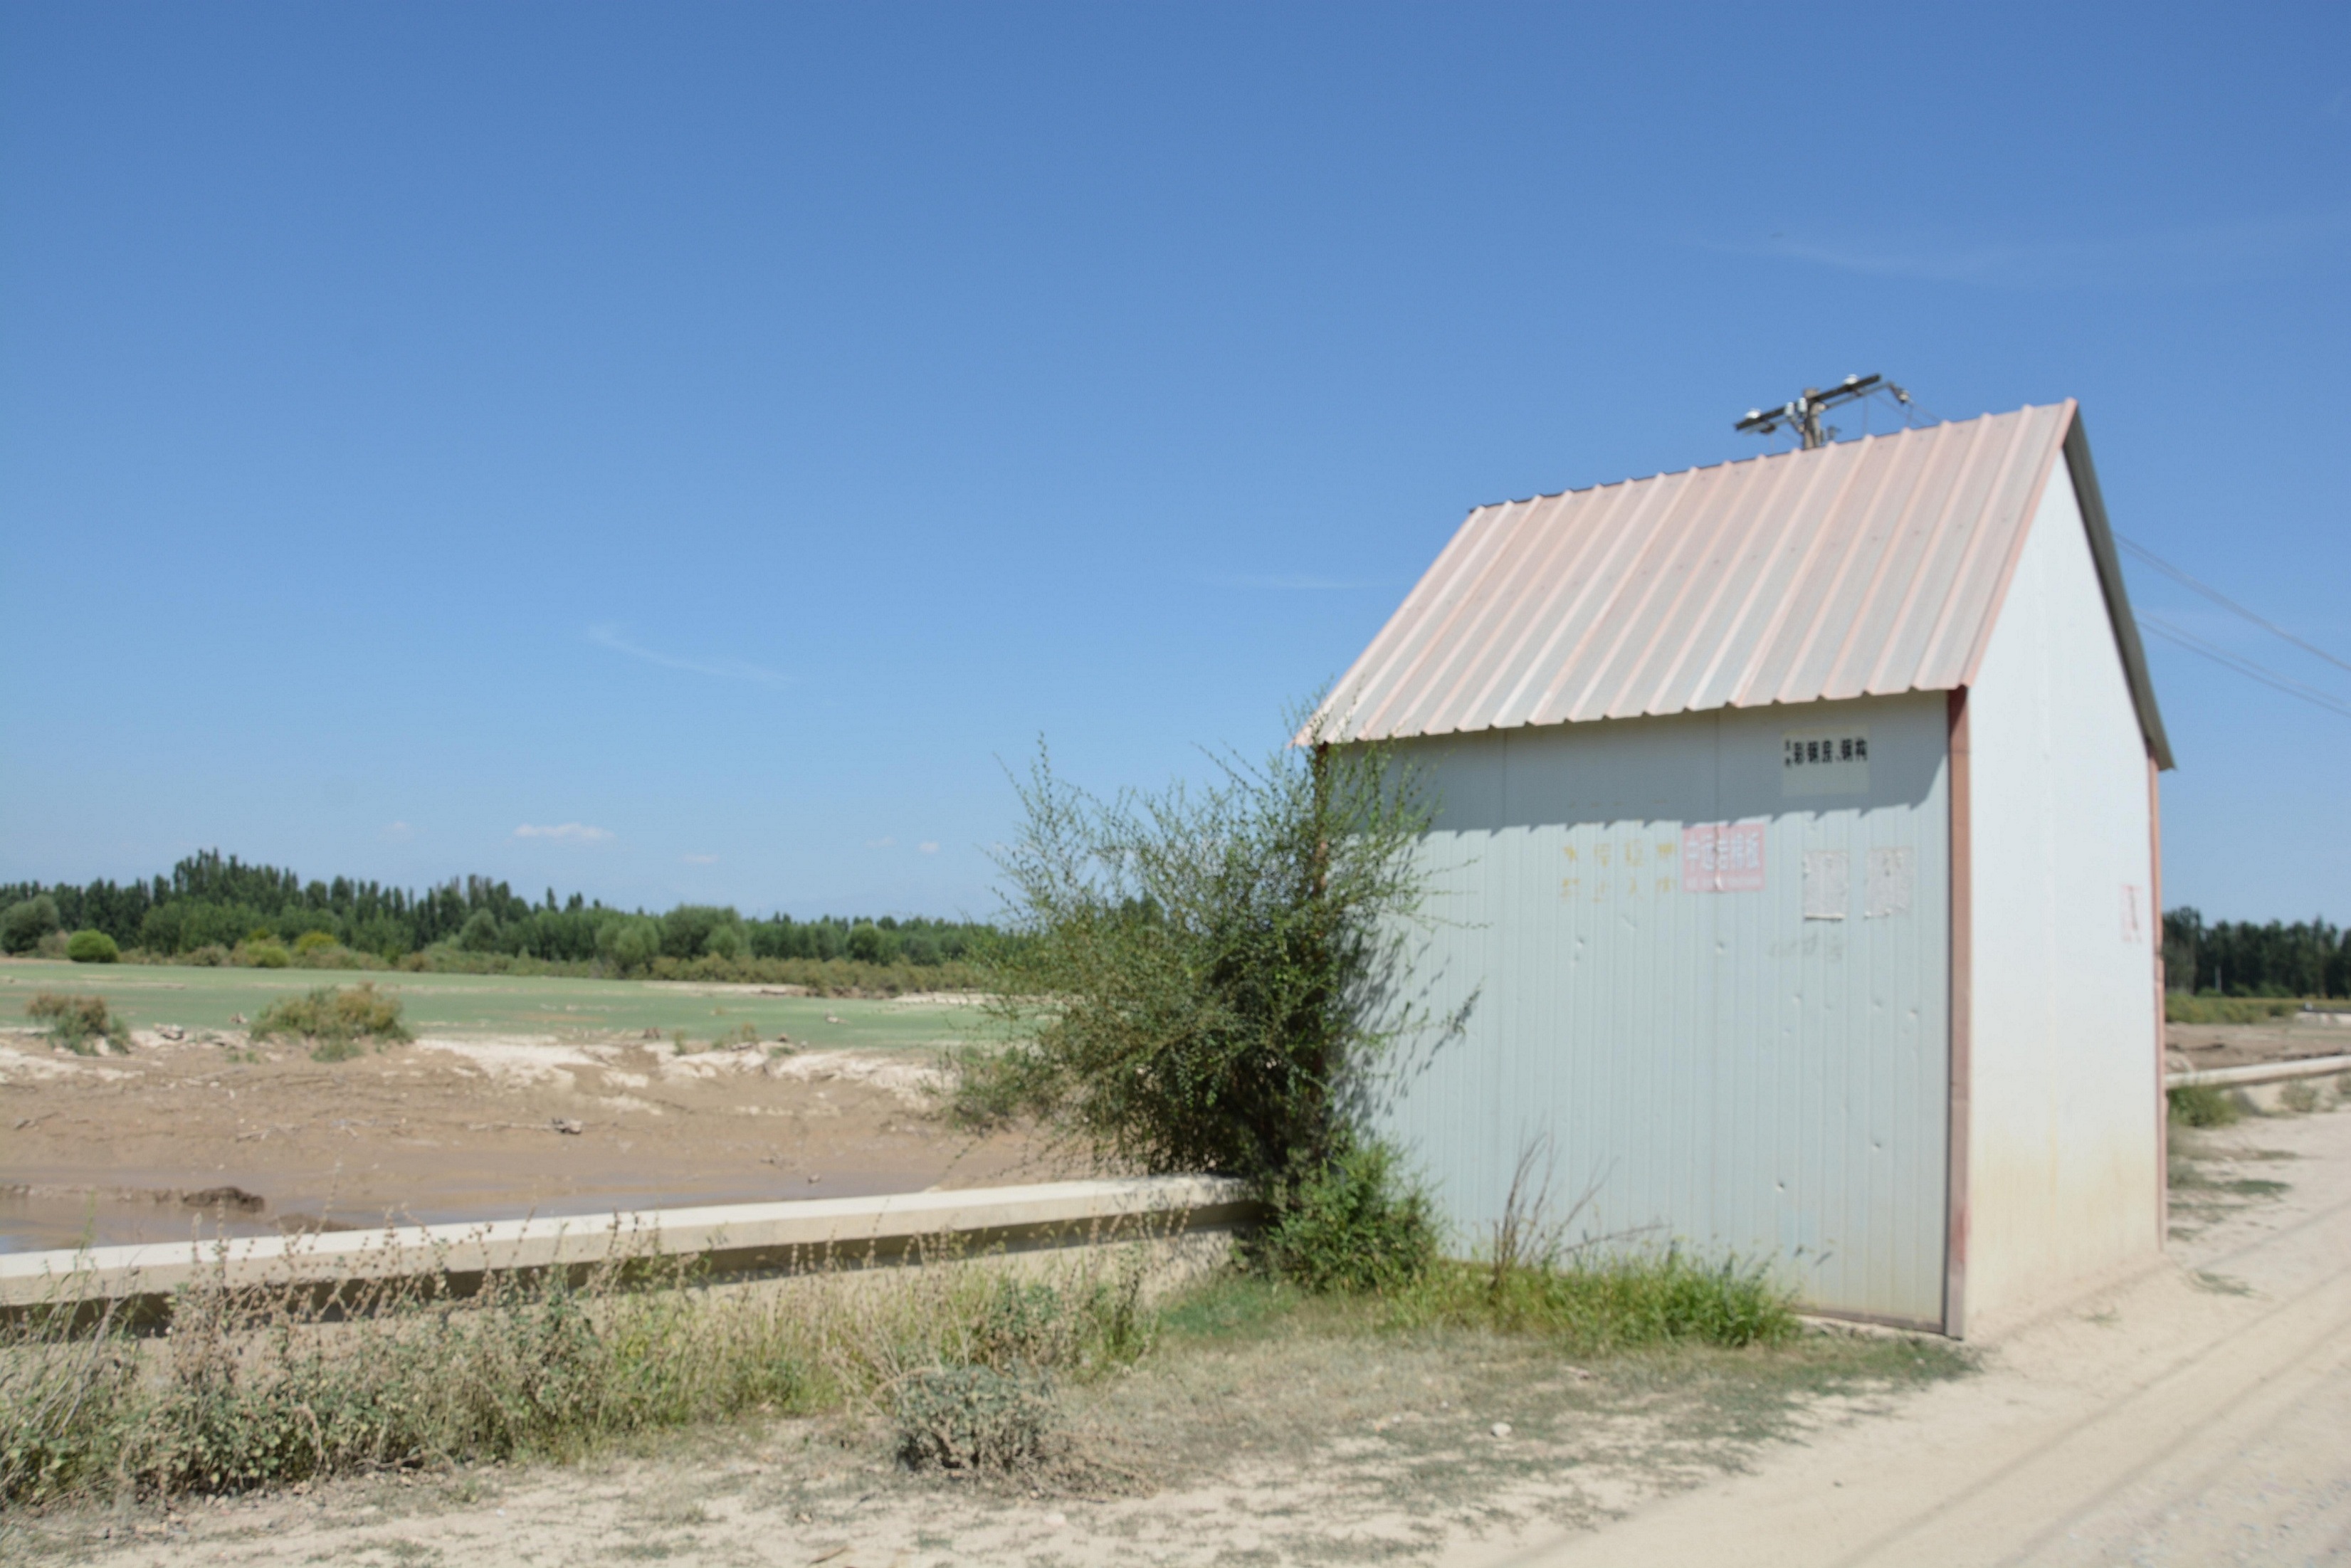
[1382,696,1949,1324]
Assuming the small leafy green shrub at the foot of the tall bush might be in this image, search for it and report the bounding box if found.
[1251,1142,1436,1290]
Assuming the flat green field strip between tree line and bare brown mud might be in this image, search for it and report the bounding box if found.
[0,959,983,1051]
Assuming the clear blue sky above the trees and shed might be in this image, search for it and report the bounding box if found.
[0,5,2351,919]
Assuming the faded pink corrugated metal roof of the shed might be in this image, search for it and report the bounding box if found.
[1317,399,2170,767]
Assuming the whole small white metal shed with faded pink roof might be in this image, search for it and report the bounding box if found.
[1319,402,2170,1335]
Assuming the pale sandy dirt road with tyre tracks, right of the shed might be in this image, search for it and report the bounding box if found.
[1448,1112,2351,1568]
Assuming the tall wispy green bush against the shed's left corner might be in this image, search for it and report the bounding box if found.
[962,710,1429,1279]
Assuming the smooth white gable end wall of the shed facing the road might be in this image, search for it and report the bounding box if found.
[1965,461,2163,1333]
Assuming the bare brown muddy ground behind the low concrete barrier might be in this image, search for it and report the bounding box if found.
[0,1030,1051,1248]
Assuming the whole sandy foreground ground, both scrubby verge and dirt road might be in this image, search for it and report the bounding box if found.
[18,1112,2351,1568]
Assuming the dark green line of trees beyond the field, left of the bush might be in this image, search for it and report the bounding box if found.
[0,848,994,971]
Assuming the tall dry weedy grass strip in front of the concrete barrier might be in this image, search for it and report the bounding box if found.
[0,1246,1150,1509]
